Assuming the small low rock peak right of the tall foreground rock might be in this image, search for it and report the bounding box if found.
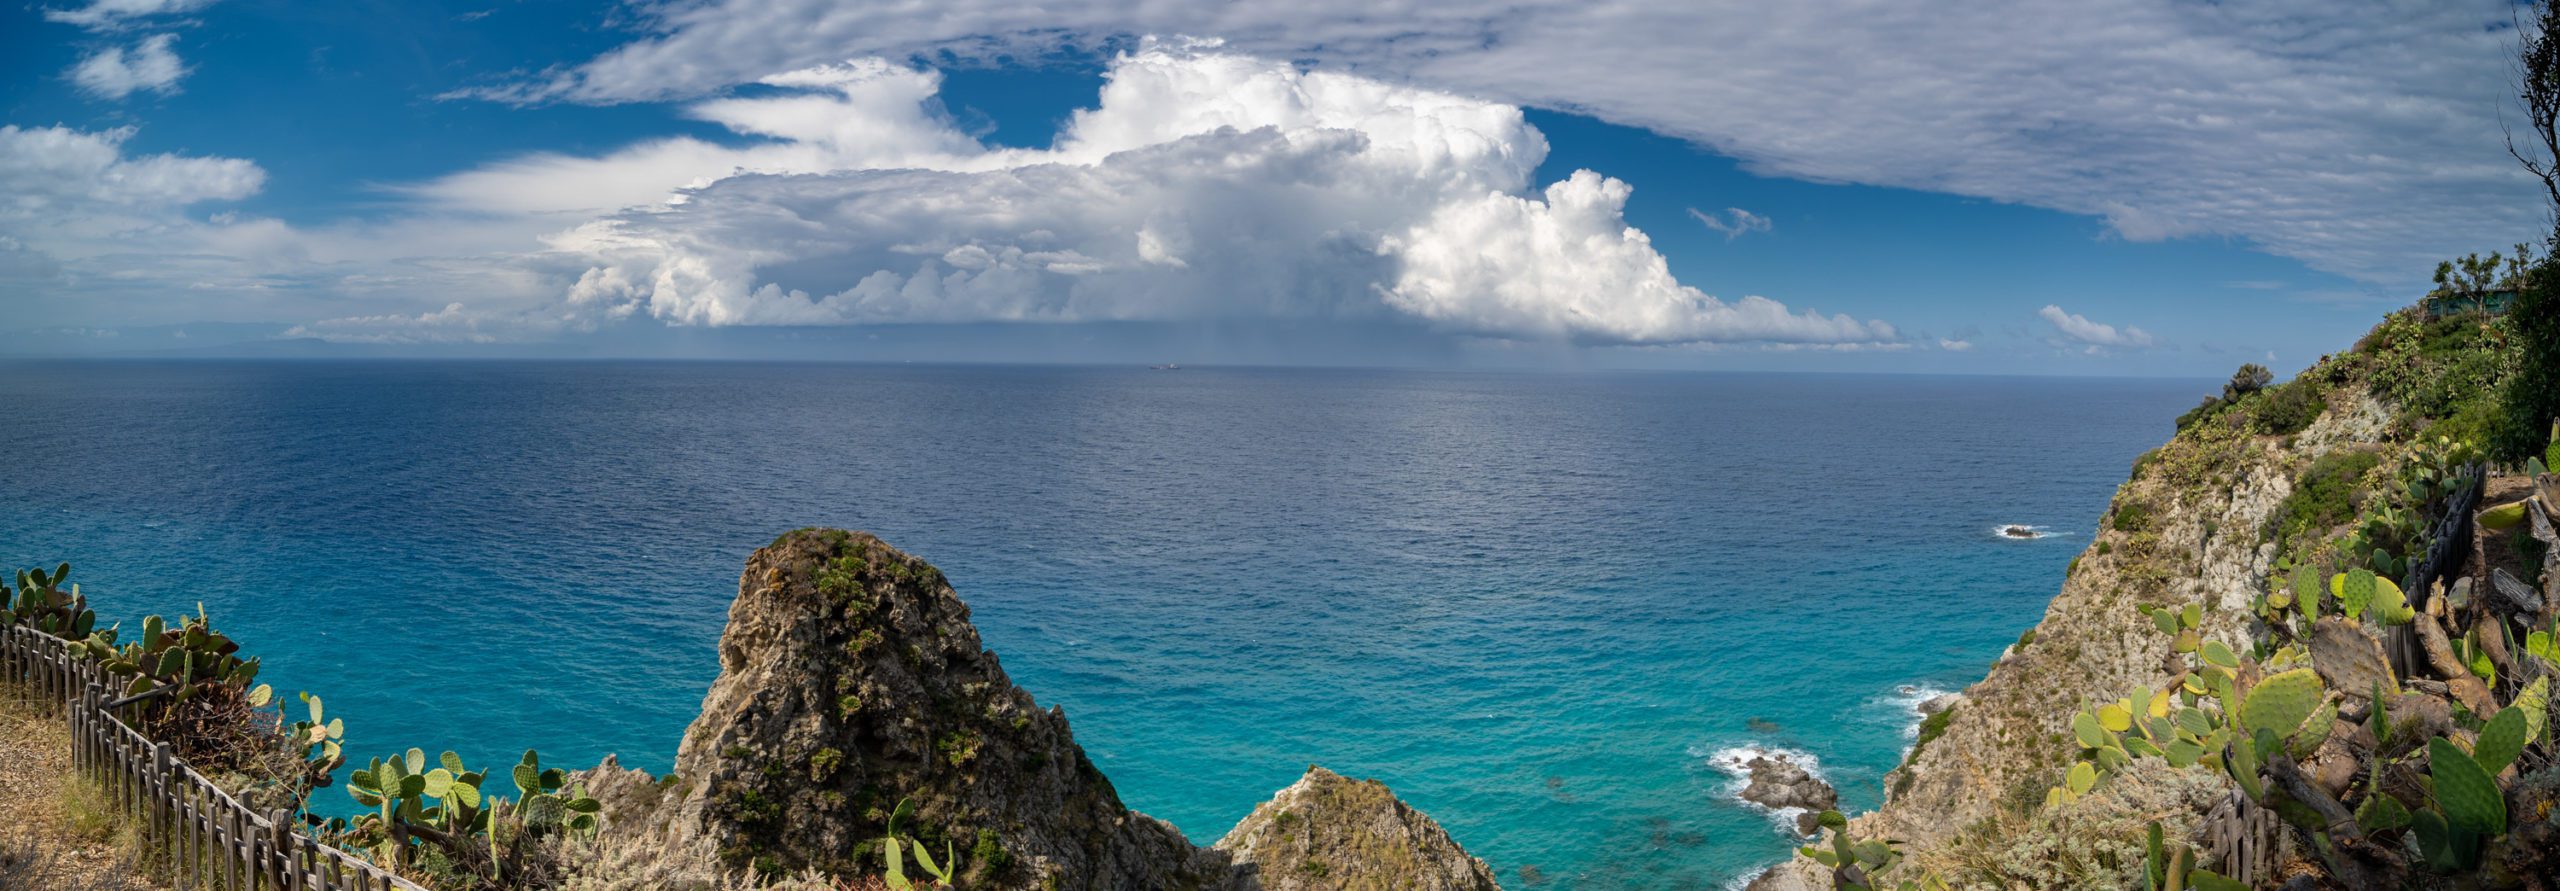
[1216,766,1498,891]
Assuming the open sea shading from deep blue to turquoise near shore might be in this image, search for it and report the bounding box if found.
[0,361,2209,888]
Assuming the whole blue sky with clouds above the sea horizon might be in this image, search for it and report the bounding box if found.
[0,0,2542,376]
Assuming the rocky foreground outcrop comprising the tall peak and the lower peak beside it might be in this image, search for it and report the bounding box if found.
[581,530,1492,888]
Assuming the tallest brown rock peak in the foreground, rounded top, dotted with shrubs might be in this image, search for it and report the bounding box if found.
[650,530,1229,888]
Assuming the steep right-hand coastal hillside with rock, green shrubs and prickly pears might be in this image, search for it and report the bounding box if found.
[1756,307,2560,888]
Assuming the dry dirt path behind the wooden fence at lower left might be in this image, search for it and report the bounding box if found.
[0,686,161,891]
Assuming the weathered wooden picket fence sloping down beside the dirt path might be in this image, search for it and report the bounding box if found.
[0,625,425,891]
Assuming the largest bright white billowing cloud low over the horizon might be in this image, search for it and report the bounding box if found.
[535,44,1897,343]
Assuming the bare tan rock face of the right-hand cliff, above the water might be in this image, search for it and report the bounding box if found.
[1851,392,2391,853]
